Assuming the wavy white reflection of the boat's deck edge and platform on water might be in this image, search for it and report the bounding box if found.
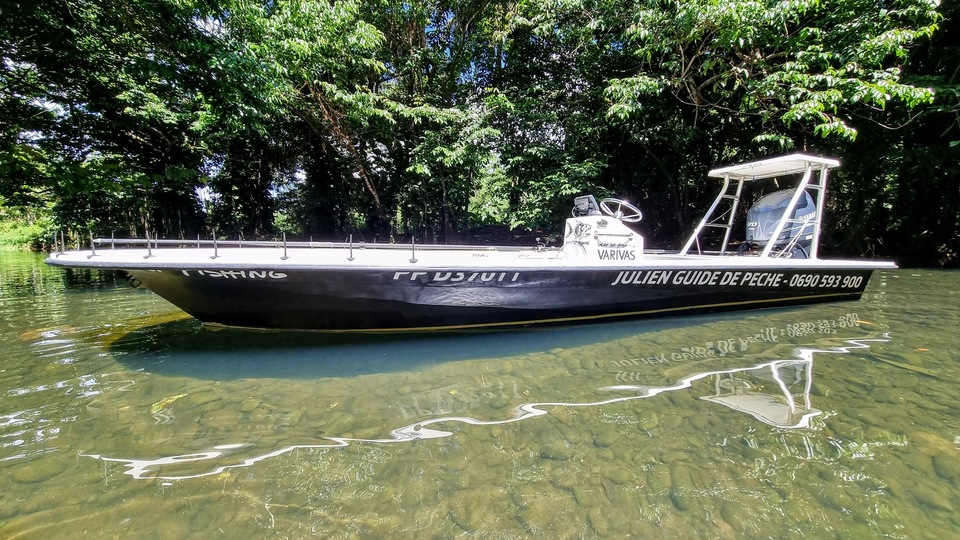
[90,318,890,480]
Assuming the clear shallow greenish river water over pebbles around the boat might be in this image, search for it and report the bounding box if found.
[0,253,960,538]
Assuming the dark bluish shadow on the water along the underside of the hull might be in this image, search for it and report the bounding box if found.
[110,308,797,380]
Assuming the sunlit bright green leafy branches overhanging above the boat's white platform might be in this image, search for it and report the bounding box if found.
[606,0,938,141]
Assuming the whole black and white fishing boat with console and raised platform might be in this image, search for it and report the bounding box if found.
[46,150,896,332]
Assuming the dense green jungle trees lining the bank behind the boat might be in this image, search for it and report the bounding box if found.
[0,0,960,266]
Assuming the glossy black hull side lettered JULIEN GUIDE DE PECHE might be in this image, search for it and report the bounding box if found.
[126,266,872,332]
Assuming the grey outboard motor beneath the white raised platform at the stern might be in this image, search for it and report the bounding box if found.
[738,189,817,258]
